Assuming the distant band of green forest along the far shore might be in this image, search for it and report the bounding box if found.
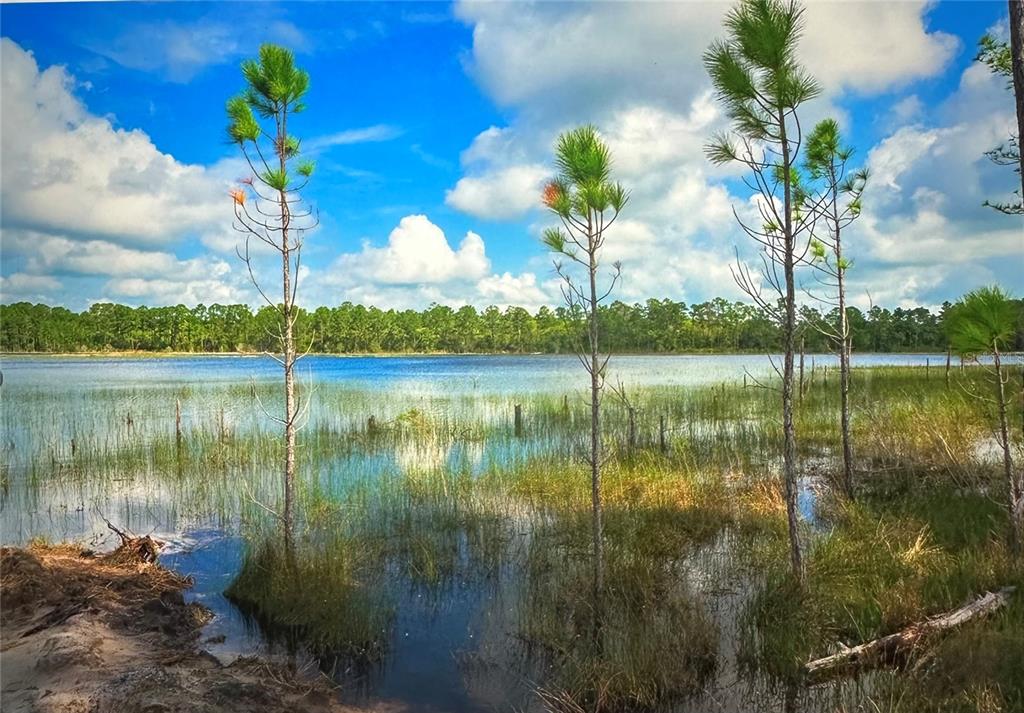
[0,298,1024,353]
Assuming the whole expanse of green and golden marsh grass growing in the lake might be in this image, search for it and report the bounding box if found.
[2,368,1024,711]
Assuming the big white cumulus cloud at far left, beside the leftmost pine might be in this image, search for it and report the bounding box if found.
[0,39,253,304]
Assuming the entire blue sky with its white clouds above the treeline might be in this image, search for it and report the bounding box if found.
[0,2,1024,308]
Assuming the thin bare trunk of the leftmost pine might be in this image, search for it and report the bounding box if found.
[278,114,298,553]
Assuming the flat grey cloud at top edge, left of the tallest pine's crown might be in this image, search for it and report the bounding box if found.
[456,2,725,115]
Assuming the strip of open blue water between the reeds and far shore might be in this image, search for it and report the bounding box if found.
[0,354,946,394]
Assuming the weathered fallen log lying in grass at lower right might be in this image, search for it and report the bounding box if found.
[804,587,1015,683]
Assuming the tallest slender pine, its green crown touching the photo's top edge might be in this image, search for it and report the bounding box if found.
[705,0,821,580]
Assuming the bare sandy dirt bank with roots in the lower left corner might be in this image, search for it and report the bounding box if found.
[0,545,376,713]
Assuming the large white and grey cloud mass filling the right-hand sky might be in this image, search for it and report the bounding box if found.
[449,0,1020,301]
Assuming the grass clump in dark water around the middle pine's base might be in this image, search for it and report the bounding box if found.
[518,509,720,710]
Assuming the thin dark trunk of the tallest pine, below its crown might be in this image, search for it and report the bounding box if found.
[778,110,804,583]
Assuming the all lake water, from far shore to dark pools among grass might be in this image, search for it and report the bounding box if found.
[0,354,945,713]
